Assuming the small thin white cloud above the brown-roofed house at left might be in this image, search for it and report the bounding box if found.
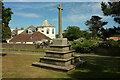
[15,12,40,18]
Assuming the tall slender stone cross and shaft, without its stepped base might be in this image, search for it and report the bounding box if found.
[57,4,63,38]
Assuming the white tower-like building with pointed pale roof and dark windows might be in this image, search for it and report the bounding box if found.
[37,19,55,39]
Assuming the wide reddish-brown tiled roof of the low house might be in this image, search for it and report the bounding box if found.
[10,31,51,42]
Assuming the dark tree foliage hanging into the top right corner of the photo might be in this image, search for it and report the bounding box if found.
[101,1,120,24]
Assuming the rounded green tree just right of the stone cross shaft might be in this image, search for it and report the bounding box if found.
[63,26,82,41]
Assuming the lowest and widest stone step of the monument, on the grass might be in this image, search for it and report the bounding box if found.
[32,62,75,72]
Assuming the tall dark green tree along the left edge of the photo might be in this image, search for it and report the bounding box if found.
[2,3,13,40]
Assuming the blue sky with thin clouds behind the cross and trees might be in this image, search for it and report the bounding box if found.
[4,2,118,33]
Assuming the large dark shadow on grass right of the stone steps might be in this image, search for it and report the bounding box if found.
[68,57,120,79]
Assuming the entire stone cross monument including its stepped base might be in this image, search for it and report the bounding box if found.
[32,4,83,72]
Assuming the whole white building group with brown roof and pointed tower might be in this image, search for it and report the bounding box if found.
[7,19,55,44]
